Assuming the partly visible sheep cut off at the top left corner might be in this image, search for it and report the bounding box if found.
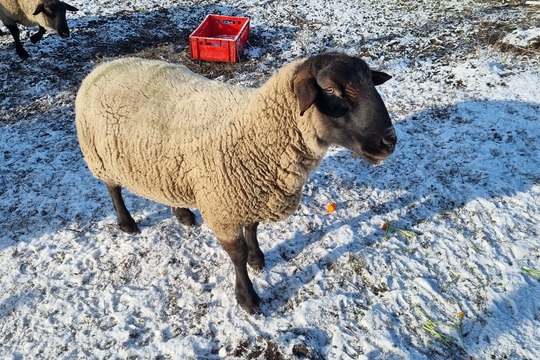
[0,0,78,59]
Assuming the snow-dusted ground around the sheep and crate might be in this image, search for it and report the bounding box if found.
[0,0,540,360]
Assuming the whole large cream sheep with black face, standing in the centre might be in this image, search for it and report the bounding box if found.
[75,53,397,313]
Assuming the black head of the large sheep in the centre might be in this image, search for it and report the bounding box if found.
[293,53,397,164]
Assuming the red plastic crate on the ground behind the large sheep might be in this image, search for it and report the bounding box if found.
[189,14,249,62]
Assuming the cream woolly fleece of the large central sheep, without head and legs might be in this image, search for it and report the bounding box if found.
[75,58,328,240]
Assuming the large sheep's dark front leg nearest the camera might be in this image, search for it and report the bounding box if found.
[218,232,261,314]
